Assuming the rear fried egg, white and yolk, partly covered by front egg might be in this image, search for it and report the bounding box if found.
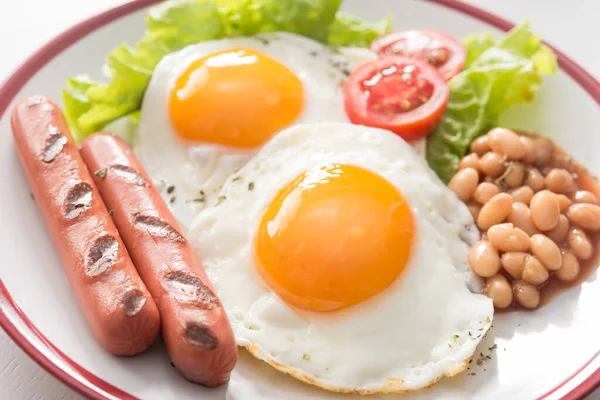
[134,33,375,227]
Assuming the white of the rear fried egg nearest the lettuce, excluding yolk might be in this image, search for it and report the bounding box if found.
[134,32,375,228]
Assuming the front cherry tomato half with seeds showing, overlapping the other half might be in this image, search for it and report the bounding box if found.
[344,56,450,140]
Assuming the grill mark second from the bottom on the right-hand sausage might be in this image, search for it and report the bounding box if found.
[162,271,218,309]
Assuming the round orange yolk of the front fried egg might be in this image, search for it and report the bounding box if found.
[254,164,415,311]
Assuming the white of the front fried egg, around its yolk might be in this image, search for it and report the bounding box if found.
[189,123,494,394]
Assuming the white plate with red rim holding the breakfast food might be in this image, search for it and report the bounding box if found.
[0,0,600,400]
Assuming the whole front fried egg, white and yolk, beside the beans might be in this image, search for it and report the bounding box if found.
[189,123,494,394]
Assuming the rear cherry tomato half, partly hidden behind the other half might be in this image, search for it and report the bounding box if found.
[371,31,467,80]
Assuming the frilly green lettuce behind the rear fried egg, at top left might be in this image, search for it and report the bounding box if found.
[63,0,391,141]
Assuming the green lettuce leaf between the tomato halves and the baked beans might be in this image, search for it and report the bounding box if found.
[426,23,557,182]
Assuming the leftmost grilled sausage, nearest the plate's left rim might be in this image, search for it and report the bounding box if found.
[11,96,160,356]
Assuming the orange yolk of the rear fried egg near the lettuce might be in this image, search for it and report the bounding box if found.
[169,48,304,148]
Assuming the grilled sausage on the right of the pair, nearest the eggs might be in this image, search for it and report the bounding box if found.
[81,133,237,386]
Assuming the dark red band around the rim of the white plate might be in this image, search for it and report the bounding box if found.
[0,0,600,400]
